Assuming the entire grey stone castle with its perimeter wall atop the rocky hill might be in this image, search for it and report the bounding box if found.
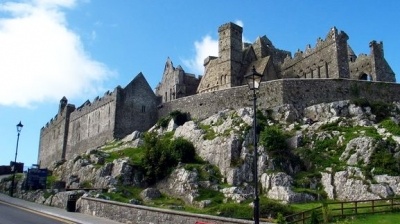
[38,23,400,168]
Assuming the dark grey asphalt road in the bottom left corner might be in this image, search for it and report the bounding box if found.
[0,201,75,224]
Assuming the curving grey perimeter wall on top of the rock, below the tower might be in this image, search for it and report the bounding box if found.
[158,79,400,119]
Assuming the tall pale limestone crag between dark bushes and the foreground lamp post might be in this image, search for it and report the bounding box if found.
[174,110,249,185]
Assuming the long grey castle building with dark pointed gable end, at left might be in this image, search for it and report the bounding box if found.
[38,73,158,167]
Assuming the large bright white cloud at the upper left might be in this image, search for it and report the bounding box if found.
[0,0,112,107]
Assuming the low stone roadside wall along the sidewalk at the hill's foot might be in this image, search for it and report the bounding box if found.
[78,197,263,224]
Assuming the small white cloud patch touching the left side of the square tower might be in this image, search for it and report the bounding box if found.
[183,35,218,75]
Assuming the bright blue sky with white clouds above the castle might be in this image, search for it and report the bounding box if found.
[0,0,400,167]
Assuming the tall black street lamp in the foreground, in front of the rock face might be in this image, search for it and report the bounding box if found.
[244,66,262,224]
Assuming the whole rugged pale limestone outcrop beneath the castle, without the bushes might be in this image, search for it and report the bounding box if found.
[6,101,400,207]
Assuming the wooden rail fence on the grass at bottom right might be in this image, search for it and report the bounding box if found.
[285,198,400,224]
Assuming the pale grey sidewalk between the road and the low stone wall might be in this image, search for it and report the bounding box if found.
[0,193,120,224]
